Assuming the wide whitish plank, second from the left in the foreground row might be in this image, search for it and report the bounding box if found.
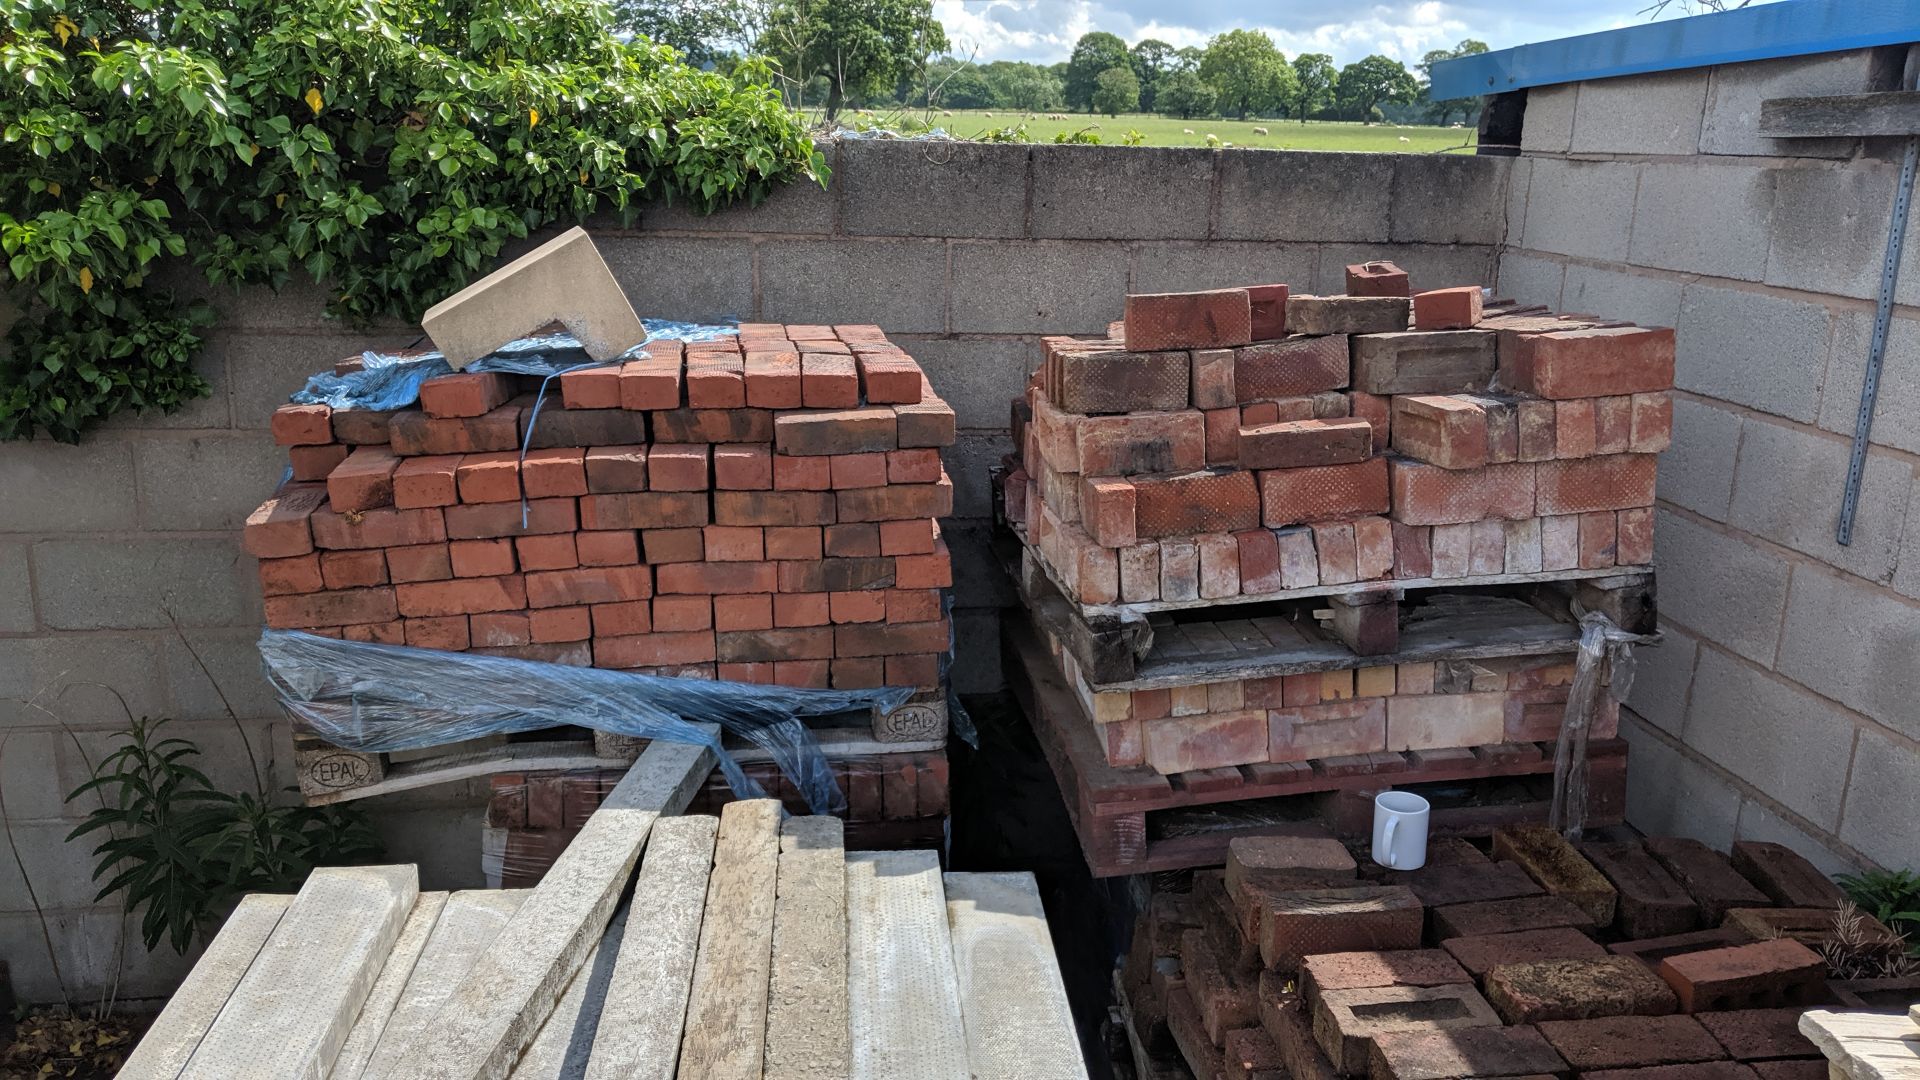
[180,867,420,1080]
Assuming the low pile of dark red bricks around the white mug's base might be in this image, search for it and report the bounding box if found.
[1116,826,1866,1080]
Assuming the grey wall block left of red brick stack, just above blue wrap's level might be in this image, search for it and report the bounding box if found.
[33,534,259,630]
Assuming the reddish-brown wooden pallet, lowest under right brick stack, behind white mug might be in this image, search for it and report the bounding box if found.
[1000,617,1626,878]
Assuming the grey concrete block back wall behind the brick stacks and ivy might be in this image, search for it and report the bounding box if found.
[0,142,1509,1001]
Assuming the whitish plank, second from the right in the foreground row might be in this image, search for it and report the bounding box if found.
[847,851,968,1080]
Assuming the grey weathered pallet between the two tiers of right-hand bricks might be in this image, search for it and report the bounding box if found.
[995,518,1659,690]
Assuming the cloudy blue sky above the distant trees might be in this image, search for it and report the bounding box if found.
[933,0,1766,67]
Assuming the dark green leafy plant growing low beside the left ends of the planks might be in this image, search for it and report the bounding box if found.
[67,719,380,953]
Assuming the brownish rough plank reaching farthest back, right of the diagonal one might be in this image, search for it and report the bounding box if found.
[678,799,780,1080]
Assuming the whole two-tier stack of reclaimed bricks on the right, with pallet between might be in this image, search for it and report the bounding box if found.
[1000,263,1674,872]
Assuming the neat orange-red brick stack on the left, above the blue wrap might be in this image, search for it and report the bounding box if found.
[246,323,954,688]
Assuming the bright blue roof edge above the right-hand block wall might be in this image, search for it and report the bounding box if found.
[1432,0,1920,100]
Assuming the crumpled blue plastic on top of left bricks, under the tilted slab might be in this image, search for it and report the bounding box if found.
[288,319,739,411]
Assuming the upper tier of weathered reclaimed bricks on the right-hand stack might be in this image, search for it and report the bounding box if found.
[1006,263,1674,603]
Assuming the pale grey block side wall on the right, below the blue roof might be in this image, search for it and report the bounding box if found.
[1500,50,1920,871]
